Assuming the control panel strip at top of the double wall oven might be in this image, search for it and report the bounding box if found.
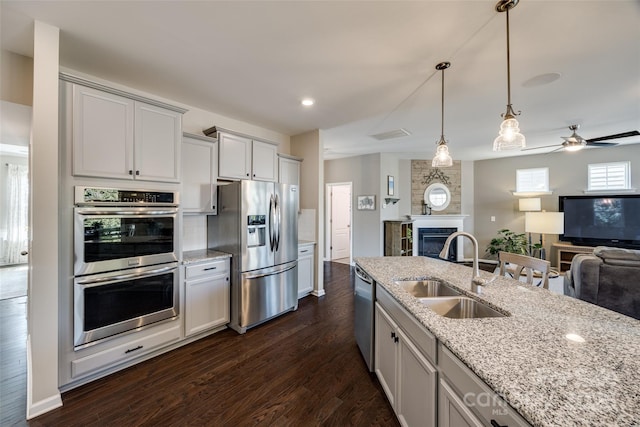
[75,187,178,206]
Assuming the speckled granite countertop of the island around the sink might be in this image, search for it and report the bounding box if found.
[356,257,640,427]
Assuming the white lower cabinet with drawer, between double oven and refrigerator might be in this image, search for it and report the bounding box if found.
[184,258,230,336]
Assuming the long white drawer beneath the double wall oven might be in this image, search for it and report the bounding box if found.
[71,321,180,378]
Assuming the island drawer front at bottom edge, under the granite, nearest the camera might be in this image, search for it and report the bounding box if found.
[438,344,530,427]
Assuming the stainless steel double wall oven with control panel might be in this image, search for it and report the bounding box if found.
[73,187,179,349]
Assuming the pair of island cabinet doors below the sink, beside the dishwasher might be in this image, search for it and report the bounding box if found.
[374,303,437,426]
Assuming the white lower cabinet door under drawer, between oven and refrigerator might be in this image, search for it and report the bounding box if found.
[185,275,229,335]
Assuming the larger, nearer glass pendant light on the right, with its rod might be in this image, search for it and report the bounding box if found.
[493,0,526,151]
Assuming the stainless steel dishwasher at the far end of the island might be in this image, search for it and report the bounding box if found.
[354,264,376,372]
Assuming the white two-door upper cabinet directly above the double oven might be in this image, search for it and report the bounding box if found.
[73,84,182,182]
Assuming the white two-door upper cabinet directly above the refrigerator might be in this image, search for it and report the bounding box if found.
[218,132,278,182]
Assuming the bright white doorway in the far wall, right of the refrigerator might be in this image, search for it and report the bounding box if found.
[325,182,351,264]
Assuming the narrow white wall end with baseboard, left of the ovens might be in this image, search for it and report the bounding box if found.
[27,21,62,419]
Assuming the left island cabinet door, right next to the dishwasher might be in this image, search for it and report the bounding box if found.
[374,303,399,411]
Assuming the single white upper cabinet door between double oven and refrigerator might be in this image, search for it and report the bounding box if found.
[180,136,218,214]
